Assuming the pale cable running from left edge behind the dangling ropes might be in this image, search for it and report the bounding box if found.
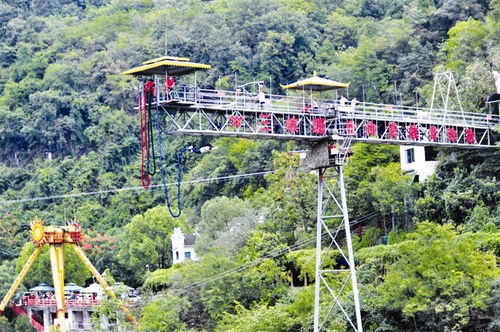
[0,170,274,205]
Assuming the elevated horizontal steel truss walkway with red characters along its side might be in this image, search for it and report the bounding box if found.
[146,87,500,148]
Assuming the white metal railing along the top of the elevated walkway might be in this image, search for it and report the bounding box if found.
[154,86,500,128]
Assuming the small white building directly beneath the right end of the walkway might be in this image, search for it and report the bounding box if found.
[399,145,437,182]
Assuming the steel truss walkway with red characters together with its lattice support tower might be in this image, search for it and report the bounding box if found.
[147,83,500,332]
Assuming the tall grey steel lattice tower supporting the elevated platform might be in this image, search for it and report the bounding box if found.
[312,139,363,332]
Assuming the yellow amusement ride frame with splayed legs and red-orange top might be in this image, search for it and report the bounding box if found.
[0,219,136,331]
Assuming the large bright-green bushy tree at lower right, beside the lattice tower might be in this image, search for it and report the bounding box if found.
[364,222,499,330]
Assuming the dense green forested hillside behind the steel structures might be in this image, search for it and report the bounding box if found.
[0,0,500,331]
